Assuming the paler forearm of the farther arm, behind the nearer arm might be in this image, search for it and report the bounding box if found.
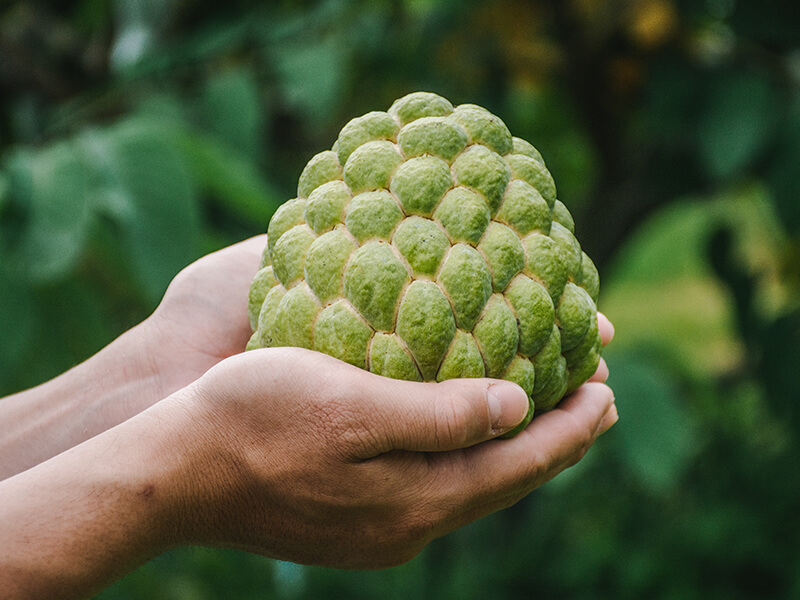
[0,322,165,480]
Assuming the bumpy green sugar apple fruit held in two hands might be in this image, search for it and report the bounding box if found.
[248,92,601,434]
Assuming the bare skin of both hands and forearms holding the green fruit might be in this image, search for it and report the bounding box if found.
[0,238,617,598]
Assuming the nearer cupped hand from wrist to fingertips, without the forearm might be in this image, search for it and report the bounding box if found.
[166,348,616,568]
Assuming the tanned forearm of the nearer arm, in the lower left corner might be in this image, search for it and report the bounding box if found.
[0,396,190,599]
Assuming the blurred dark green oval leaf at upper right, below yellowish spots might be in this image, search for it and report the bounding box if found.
[697,72,777,178]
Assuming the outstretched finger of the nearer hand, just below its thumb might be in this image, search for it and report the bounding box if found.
[439,383,614,502]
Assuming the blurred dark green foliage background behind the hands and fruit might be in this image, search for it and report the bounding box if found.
[0,0,800,600]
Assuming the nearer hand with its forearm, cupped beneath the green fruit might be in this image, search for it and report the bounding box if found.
[0,317,617,598]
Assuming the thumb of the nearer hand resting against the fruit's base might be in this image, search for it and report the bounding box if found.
[360,376,529,452]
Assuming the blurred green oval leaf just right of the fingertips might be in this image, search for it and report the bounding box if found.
[606,353,696,493]
